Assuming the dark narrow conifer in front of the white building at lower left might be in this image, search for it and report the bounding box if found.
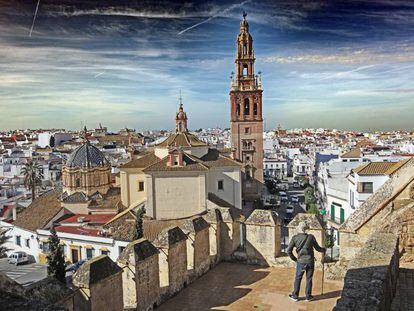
[46,227,66,283]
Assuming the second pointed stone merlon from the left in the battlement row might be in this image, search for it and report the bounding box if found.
[118,239,160,310]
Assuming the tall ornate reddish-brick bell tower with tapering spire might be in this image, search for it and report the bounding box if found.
[230,13,263,200]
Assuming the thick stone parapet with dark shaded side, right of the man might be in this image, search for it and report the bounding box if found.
[334,232,399,311]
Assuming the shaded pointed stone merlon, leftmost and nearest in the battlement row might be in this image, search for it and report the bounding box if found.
[73,255,124,311]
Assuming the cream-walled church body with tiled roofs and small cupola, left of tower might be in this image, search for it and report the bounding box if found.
[120,105,242,220]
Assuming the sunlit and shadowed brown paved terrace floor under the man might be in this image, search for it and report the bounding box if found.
[157,263,343,311]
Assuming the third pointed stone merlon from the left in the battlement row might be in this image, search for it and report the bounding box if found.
[153,227,187,302]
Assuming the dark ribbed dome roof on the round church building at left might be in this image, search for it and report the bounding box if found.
[66,141,110,167]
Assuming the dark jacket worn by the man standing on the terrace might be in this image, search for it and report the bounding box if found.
[287,233,325,264]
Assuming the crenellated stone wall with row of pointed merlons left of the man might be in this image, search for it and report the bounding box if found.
[63,207,288,311]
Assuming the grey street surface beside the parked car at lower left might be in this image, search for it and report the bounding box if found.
[0,258,47,287]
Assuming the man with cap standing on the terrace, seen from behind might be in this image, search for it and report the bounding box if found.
[287,222,326,301]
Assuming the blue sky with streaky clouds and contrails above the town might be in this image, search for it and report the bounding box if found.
[0,0,414,131]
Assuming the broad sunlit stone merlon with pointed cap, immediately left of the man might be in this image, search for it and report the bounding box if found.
[245,209,281,265]
